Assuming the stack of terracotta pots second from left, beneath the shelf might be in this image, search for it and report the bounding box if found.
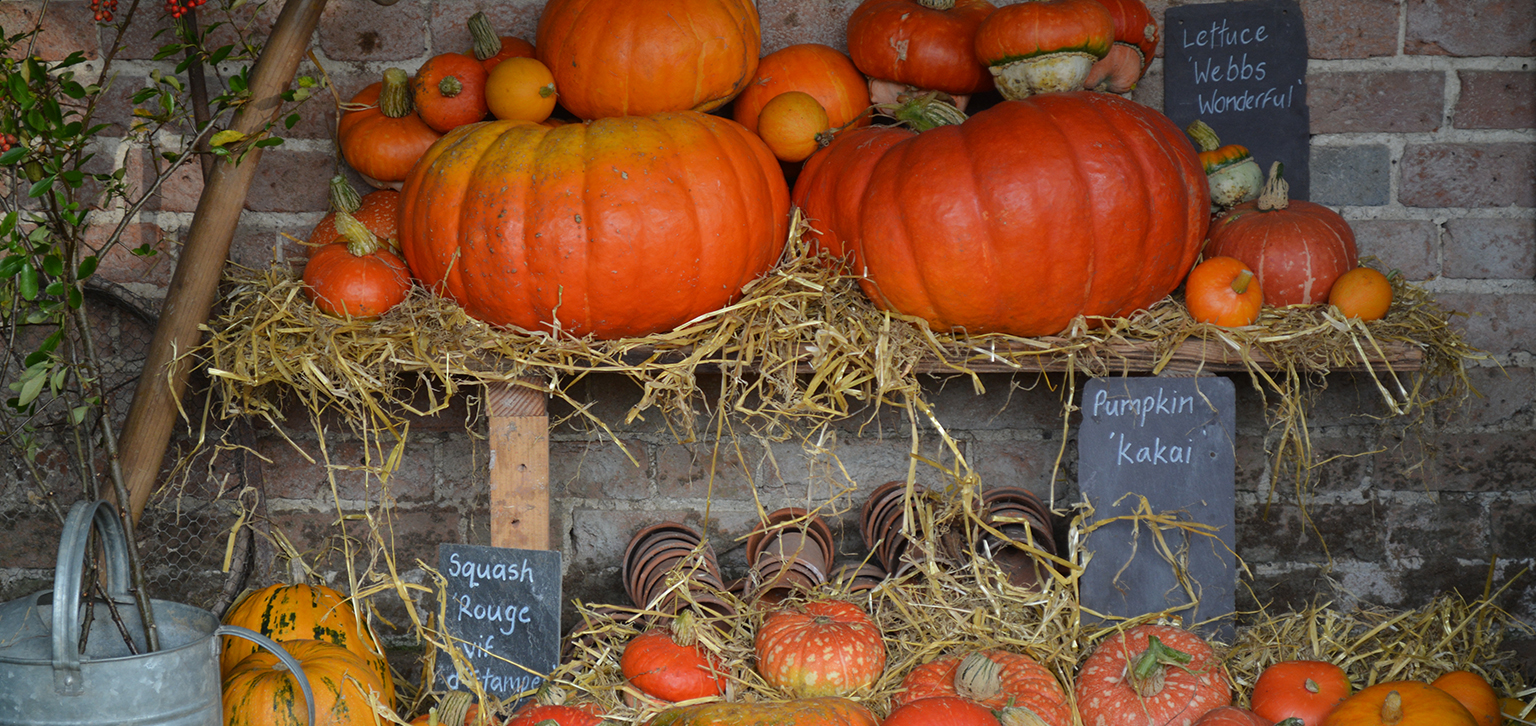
[743,507,834,605]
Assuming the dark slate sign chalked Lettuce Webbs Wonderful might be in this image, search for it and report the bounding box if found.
[1163,0,1312,200]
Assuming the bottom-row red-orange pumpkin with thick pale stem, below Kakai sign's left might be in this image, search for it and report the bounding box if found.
[891,651,1072,726]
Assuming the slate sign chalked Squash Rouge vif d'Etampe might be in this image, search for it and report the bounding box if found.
[435,543,561,698]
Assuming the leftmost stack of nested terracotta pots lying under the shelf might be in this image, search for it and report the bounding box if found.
[622,522,736,615]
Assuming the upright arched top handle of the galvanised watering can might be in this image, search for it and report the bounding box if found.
[54,499,127,695]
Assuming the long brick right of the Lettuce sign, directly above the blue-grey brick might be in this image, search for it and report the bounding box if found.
[1307,71,1445,134]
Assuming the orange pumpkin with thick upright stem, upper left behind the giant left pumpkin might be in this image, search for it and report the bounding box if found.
[336,75,441,186]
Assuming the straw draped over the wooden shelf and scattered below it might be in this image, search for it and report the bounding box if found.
[187,218,1519,723]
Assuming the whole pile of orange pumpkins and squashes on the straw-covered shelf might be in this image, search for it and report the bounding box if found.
[304,0,1390,348]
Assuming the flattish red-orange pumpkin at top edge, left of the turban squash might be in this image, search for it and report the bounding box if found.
[848,0,997,94]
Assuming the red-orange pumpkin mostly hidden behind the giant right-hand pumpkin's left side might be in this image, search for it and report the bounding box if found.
[793,126,917,264]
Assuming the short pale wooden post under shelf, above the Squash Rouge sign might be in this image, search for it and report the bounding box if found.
[485,384,550,549]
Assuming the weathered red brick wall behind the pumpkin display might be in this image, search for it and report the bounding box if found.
[0,0,1536,675]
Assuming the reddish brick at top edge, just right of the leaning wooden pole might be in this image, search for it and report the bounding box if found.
[319,0,429,66]
